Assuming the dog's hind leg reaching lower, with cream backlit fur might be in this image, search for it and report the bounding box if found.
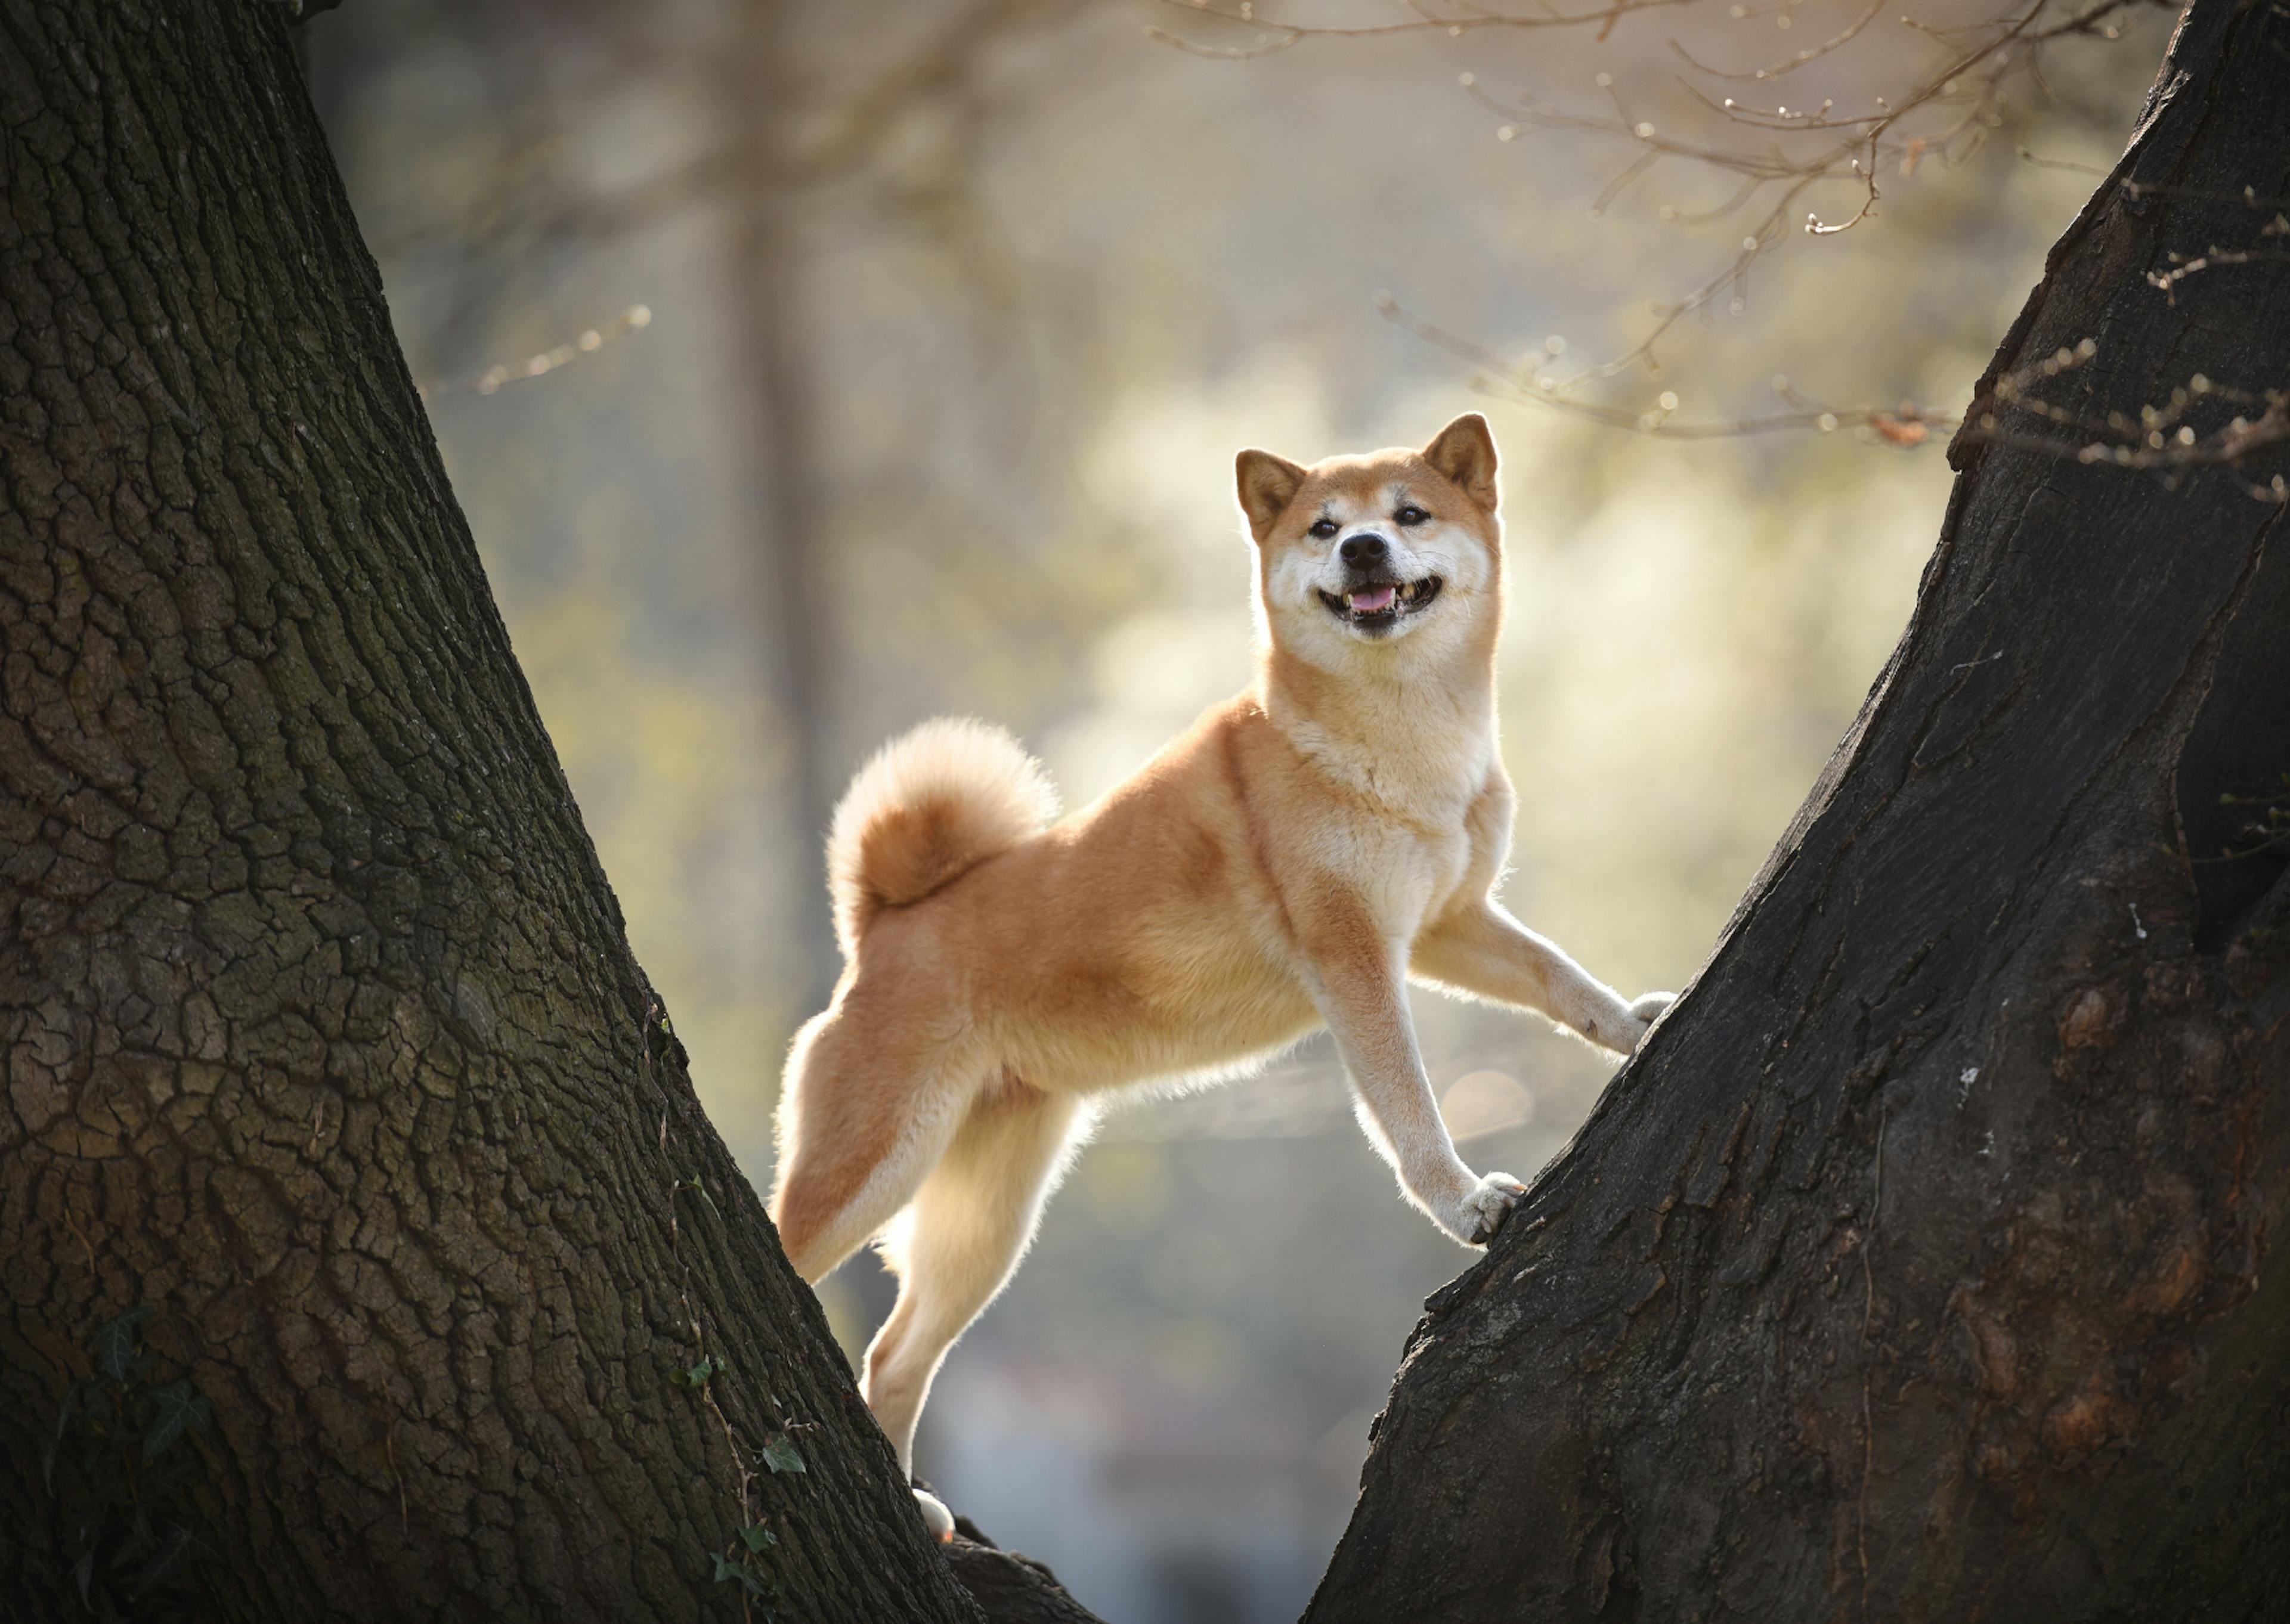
[866,1074,1088,1484]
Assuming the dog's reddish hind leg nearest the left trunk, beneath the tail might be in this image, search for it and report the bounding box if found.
[772,1003,985,1285]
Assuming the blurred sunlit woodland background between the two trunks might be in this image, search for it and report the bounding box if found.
[302,0,2168,1624]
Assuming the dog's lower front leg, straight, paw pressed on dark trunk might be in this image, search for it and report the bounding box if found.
[1303,898,1527,1246]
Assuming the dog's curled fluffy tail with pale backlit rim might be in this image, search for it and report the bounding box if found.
[827,717,1058,957]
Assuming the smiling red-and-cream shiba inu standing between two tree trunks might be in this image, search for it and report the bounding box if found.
[772,414,1669,1530]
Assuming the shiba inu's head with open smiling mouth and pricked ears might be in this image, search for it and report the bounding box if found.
[1237,413,1502,669]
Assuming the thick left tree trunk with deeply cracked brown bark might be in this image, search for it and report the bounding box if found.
[0,0,978,1624]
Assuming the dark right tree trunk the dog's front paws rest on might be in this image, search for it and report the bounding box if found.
[1308,0,2290,1624]
